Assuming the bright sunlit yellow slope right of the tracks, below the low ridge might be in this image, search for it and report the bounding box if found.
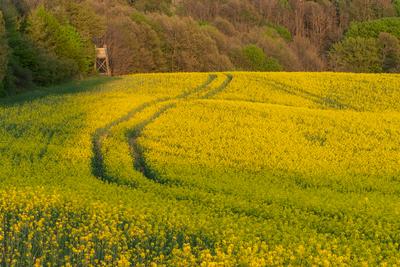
[141,101,400,193]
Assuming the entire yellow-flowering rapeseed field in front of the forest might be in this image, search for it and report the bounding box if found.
[0,72,400,266]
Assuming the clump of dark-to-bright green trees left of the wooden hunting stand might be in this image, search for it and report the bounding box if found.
[0,4,94,94]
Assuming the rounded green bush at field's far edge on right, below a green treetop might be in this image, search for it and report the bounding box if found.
[329,37,383,72]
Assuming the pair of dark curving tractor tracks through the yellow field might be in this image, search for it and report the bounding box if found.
[91,74,233,187]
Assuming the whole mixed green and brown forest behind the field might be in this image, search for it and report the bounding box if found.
[0,0,400,96]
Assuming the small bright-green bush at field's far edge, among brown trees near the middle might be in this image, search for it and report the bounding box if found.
[242,44,282,71]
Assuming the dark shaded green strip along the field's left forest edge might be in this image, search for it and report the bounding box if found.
[0,77,121,107]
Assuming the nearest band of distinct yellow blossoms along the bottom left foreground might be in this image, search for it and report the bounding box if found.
[4,188,370,266]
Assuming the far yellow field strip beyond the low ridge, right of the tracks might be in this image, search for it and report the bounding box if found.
[218,73,400,112]
